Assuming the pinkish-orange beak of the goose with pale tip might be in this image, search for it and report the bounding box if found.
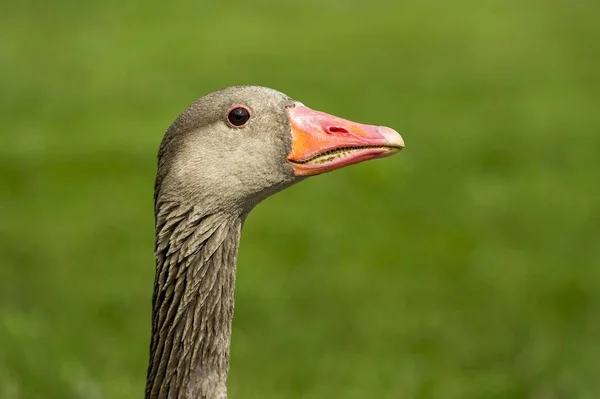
[287,106,404,176]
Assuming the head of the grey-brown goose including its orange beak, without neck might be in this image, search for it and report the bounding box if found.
[155,86,404,214]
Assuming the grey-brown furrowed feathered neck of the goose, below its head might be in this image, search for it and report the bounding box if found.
[146,202,242,399]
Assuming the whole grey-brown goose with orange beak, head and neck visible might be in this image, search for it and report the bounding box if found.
[145,86,404,399]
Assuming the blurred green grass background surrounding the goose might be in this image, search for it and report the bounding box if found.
[0,0,600,399]
